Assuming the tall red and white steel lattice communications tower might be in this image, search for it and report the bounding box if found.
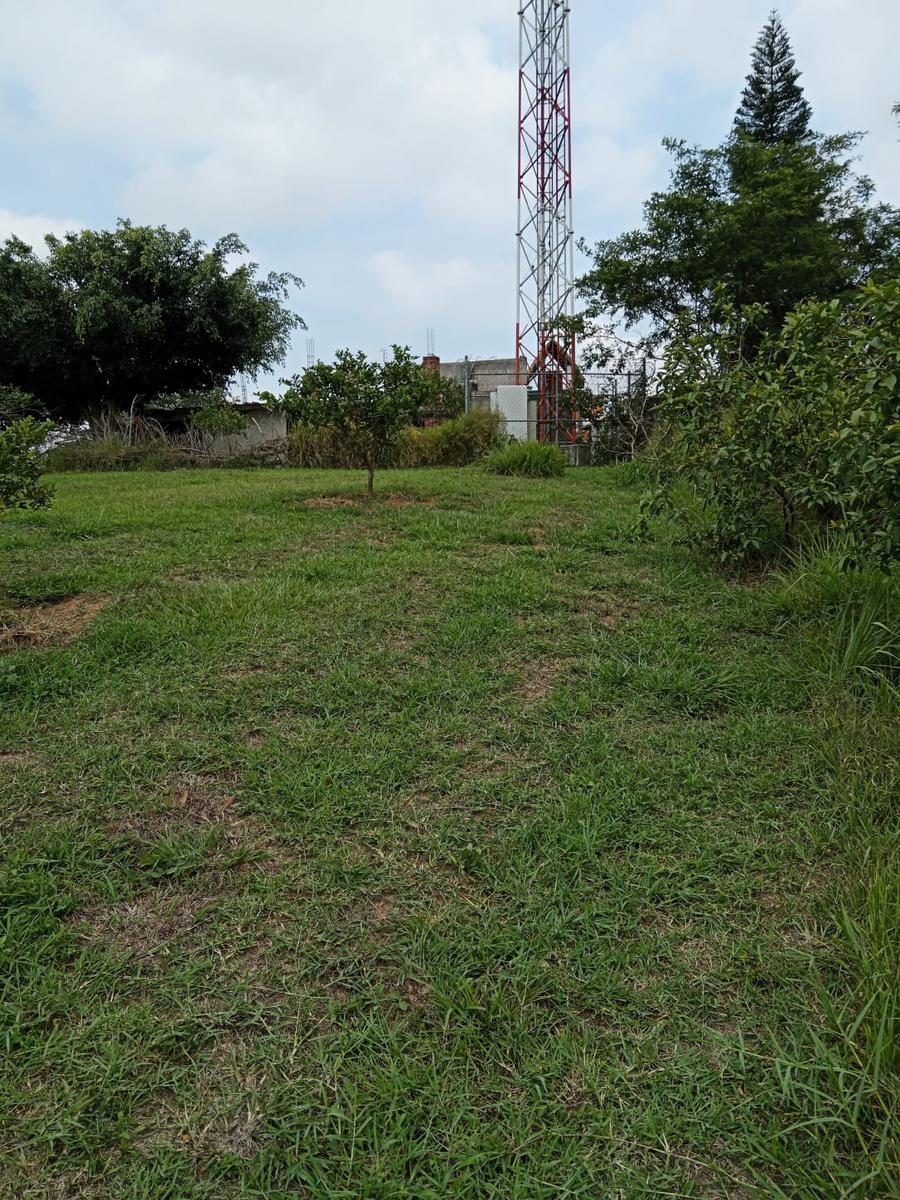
[516,0,577,442]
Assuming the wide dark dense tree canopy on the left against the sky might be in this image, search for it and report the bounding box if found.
[0,221,305,421]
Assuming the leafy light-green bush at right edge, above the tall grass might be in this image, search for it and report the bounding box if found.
[656,280,900,563]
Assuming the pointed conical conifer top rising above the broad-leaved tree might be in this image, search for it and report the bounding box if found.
[734,10,812,145]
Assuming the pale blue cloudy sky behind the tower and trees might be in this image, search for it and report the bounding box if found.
[0,0,900,379]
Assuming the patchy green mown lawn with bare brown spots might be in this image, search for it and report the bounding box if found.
[0,470,900,1200]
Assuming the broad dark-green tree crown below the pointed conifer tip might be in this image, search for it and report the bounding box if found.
[580,136,900,349]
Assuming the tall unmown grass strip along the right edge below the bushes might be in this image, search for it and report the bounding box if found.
[764,538,900,1200]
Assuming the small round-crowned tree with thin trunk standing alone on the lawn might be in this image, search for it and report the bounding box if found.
[280,346,433,496]
